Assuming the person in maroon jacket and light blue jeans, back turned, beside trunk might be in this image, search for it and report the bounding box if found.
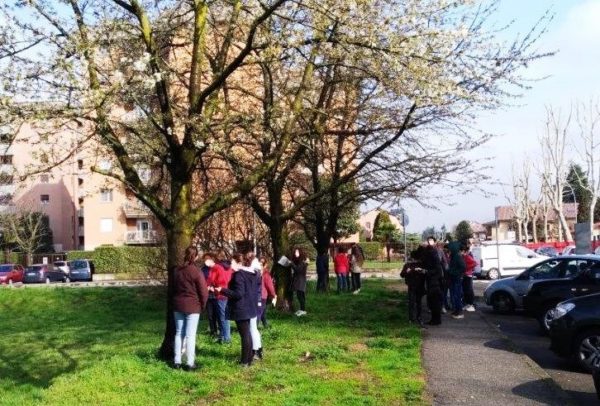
[173,246,208,371]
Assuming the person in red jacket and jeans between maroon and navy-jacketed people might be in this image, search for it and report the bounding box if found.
[204,253,233,344]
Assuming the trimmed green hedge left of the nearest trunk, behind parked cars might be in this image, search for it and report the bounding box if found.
[67,246,167,274]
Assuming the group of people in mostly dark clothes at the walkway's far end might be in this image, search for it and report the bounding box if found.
[400,237,477,326]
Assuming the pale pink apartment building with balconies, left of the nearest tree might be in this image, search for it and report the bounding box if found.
[0,125,161,251]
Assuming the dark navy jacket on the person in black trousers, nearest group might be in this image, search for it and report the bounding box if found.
[221,269,258,320]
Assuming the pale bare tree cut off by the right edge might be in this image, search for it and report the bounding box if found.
[575,99,600,235]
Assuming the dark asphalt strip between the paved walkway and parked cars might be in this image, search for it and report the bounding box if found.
[474,281,600,405]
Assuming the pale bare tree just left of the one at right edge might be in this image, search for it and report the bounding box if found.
[540,106,573,241]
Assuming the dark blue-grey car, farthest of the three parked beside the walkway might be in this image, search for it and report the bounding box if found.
[483,257,579,313]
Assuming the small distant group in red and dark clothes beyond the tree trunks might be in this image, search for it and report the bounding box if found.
[333,244,365,294]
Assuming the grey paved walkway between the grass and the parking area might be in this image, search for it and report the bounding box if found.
[423,312,570,405]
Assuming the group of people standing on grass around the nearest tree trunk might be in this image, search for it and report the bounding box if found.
[171,246,307,371]
